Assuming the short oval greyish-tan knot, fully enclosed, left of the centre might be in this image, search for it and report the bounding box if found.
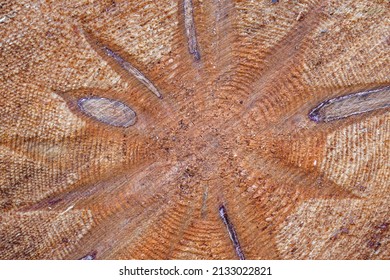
[77,97,136,127]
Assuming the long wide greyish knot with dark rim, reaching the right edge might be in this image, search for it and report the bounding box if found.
[309,86,390,122]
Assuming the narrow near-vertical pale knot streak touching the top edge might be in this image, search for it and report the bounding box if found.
[184,0,200,60]
